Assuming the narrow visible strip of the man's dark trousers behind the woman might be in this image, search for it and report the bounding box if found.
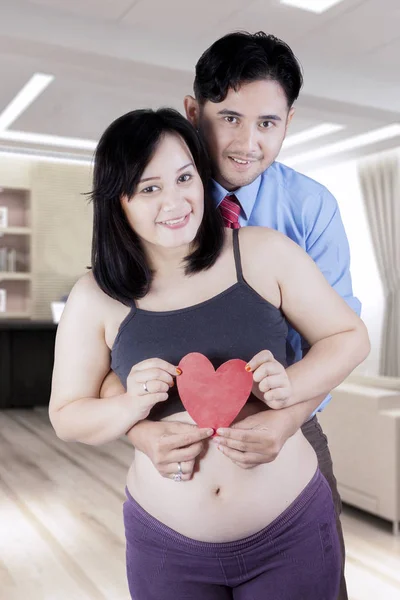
[301,417,348,600]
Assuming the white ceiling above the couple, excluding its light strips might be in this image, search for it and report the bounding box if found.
[0,0,400,166]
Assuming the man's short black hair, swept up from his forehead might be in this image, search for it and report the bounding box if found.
[194,31,303,108]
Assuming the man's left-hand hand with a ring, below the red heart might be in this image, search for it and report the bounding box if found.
[127,420,214,481]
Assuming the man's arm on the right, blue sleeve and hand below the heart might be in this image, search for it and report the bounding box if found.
[219,188,361,468]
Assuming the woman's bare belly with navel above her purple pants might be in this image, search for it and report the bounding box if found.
[127,404,317,543]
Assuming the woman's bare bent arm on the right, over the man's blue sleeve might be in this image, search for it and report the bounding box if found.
[241,228,370,406]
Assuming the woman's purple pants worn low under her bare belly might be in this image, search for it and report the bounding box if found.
[124,470,341,600]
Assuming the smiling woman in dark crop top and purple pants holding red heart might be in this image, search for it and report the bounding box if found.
[50,109,369,600]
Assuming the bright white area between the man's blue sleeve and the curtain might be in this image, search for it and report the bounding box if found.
[304,161,384,375]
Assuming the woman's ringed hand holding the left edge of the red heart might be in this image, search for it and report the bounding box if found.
[126,358,178,420]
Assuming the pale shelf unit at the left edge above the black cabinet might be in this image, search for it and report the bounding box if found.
[0,188,32,319]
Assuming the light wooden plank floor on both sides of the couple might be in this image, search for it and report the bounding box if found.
[0,409,400,600]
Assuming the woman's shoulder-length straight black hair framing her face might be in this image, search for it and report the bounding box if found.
[90,108,224,305]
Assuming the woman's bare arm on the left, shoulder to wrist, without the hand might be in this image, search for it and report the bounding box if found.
[49,274,148,444]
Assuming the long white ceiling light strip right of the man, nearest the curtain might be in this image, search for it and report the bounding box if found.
[285,123,400,166]
